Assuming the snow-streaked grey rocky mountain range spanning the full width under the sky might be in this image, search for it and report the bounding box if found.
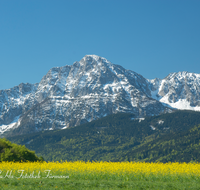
[0,55,200,135]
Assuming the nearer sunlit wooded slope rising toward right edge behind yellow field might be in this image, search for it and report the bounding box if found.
[122,121,200,162]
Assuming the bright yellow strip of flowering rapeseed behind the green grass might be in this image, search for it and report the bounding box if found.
[0,161,200,176]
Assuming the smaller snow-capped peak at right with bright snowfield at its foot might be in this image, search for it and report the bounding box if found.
[150,72,200,111]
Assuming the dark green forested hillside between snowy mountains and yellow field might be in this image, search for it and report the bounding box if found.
[8,111,200,162]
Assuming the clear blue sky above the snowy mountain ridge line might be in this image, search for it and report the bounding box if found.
[0,0,200,89]
